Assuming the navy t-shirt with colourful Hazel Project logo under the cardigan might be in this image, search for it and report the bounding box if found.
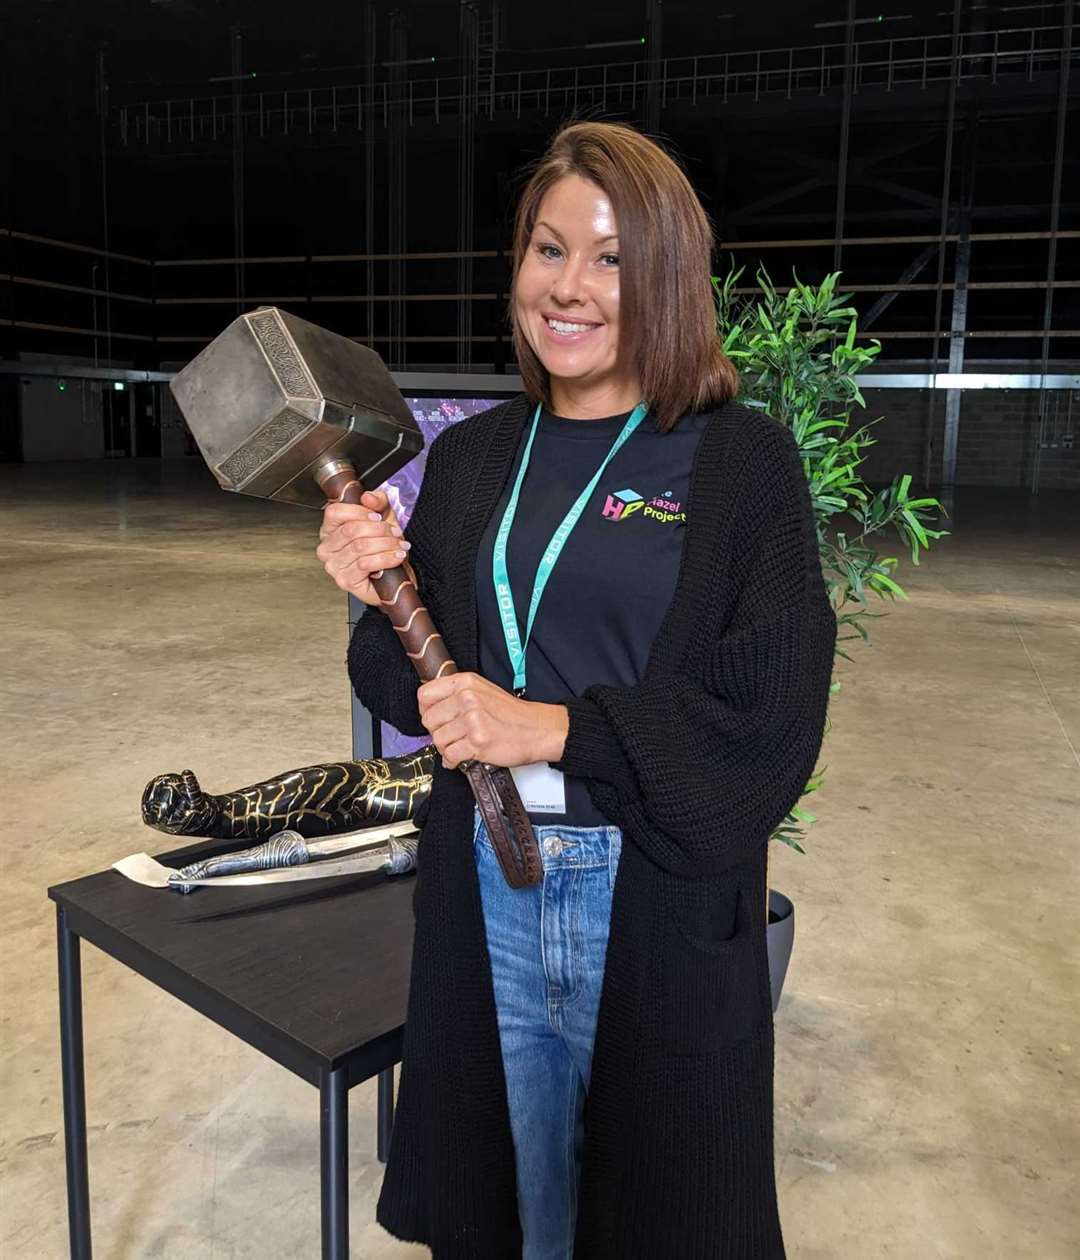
[476,408,706,827]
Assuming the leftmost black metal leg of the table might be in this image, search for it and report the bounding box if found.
[57,906,91,1260]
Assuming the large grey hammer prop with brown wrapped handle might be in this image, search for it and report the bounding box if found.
[170,306,543,888]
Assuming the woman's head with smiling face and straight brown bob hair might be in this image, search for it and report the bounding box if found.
[510,122,738,431]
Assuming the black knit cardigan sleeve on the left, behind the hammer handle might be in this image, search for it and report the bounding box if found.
[345,430,449,736]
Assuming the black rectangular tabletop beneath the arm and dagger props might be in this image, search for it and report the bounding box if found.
[49,840,416,1084]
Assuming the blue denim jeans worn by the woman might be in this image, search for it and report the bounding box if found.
[473,809,623,1260]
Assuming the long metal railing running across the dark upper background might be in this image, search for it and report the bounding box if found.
[111,26,1080,146]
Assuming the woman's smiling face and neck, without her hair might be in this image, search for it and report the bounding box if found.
[514,175,638,406]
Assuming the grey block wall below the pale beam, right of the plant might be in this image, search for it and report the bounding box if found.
[851,389,1080,491]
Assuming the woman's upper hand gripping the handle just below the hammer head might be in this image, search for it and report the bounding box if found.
[315,490,411,605]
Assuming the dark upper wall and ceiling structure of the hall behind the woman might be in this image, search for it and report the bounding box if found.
[0,0,1080,367]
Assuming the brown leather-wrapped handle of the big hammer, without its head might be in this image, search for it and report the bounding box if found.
[315,461,543,888]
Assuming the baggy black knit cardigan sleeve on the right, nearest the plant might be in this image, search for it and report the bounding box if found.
[551,426,837,876]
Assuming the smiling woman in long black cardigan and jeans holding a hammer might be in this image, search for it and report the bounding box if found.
[311,122,836,1260]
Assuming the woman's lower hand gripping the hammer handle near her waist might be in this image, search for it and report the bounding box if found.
[416,674,570,770]
